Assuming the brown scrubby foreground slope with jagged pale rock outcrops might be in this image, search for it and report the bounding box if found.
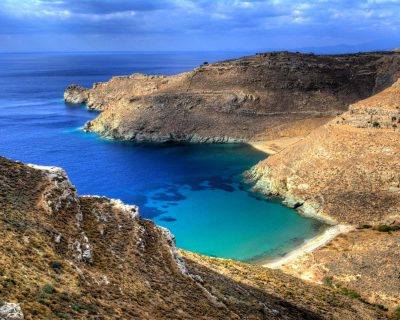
[0,158,386,319]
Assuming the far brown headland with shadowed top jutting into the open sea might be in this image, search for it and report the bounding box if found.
[64,52,400,142]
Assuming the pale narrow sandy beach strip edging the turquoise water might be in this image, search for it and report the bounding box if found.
[259,224,355,269]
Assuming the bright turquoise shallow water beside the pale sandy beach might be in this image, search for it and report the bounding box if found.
[152,184,320,261]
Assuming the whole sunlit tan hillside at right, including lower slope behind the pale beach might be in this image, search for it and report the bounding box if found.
[249,80,400,312]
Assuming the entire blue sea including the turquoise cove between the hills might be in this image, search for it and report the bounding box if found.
[0,52,322,261]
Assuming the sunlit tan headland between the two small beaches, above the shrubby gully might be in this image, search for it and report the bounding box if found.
[252,81,400,225]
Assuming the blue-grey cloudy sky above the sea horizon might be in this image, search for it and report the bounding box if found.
[0,0,400,52]
